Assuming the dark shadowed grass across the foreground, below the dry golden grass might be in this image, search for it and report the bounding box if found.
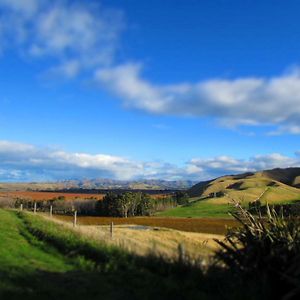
[0,214,268,300]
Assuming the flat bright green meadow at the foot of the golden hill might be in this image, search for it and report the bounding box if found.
[157,200,231,218]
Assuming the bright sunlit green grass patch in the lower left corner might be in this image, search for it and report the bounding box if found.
[0,210,79,299]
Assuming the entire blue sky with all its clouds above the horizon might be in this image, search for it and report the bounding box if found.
[0,0,300,181]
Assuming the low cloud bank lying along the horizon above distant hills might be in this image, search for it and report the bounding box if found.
[0,141,300,181]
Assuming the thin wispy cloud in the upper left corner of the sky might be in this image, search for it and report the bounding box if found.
[0,0,123,77]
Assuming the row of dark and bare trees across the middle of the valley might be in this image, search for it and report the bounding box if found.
[8,192,192,218]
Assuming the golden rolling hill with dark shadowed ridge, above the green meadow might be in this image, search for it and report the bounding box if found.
[188,168,300,203]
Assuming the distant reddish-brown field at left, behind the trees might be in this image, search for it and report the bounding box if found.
[0,191,104,201]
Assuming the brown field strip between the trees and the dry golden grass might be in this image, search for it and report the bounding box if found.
[55,215,237,235]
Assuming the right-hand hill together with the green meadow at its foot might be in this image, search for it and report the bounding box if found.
[159,168,300,217]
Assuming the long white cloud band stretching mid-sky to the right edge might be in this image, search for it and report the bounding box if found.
[95,63,300,133]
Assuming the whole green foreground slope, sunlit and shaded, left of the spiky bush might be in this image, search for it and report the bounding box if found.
[0,210,217,300]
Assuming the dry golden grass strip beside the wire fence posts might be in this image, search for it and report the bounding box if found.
[47,217,224,260]
